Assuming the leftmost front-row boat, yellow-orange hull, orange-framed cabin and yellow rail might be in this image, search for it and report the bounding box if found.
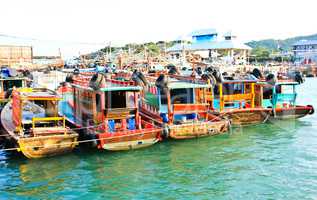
[1,88,78,158]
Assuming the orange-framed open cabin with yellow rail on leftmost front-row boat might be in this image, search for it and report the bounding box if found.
[12,88,66,136]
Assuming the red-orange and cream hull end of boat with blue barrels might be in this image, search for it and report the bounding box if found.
[98,128,161,151]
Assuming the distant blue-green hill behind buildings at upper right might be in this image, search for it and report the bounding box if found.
[247,34,317,50]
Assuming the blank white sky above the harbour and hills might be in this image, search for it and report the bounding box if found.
[0,0,317,56]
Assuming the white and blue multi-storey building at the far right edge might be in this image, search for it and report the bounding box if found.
[293,40,317,64]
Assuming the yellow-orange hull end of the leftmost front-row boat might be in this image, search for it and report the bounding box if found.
[17,134,78,158]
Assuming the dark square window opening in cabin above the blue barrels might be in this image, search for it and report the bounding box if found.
[105,91,127,108]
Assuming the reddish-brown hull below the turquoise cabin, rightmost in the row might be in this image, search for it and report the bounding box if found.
[270,106,314,120]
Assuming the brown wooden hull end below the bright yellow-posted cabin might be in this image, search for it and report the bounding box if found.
[219,108,271,126]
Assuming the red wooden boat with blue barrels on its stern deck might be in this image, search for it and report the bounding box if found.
[59,73,162,151]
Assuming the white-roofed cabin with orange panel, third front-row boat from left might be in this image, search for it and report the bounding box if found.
[141,79,210,124]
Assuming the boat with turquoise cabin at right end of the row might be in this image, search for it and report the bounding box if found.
[257,80,314,119]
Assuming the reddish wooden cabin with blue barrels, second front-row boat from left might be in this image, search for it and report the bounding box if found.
[61,81,142,132]
